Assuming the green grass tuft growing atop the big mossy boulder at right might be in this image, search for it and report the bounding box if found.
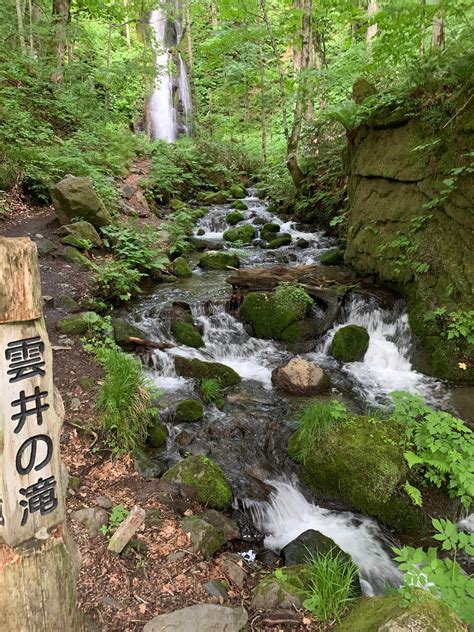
[296,399,348,464]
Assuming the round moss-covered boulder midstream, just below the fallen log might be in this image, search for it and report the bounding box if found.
[239,292,306,340]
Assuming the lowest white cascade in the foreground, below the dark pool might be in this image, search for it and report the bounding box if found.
[246,481,401,596]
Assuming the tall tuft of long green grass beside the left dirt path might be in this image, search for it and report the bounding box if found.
[95,347,154,455]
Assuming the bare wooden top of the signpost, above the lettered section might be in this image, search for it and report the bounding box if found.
[0,237,43,323]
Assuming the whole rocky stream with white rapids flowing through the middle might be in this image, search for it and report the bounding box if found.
[127,190,468,595]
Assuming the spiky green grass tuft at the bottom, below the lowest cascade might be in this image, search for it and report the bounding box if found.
[303,550,357,622]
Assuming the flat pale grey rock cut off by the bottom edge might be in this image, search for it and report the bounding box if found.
[143,604,248,632]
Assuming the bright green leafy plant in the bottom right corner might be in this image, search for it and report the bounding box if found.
[393,520,474,625]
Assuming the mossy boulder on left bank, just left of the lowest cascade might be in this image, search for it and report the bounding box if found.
[162,454,232,509]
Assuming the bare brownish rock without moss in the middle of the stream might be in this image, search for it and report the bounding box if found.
[272,357,330,395]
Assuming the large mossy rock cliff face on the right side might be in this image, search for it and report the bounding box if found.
[345,103,474,381]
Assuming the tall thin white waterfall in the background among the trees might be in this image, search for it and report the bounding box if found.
[150,0,192,143]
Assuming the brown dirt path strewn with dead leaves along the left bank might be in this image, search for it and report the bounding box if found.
[0,177,320,632]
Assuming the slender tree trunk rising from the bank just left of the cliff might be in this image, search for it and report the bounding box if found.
[286,0,313,189]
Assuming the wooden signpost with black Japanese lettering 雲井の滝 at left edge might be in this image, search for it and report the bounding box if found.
[0,238,84,632]
